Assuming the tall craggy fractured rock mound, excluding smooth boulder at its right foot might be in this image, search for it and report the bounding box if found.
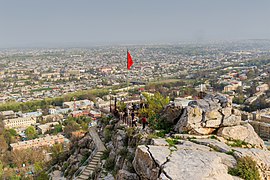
[175,94,241,135]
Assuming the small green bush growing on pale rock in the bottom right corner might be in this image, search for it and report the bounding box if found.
[228,156,260,180]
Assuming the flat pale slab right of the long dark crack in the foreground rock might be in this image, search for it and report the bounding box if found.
[163,146,236,180]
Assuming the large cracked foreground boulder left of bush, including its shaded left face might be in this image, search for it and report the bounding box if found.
[133,140,239,180]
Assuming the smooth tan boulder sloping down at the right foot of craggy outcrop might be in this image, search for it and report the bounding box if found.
[217,123,265,149]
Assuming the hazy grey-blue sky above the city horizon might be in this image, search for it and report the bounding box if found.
[0,0,270,47]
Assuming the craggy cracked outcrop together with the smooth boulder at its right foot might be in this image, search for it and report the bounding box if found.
[174,94,265,148]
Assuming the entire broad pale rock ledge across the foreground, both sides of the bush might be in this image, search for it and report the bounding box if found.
[133,135,270,180]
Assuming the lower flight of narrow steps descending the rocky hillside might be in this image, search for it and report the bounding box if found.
[76,151,103,180]
